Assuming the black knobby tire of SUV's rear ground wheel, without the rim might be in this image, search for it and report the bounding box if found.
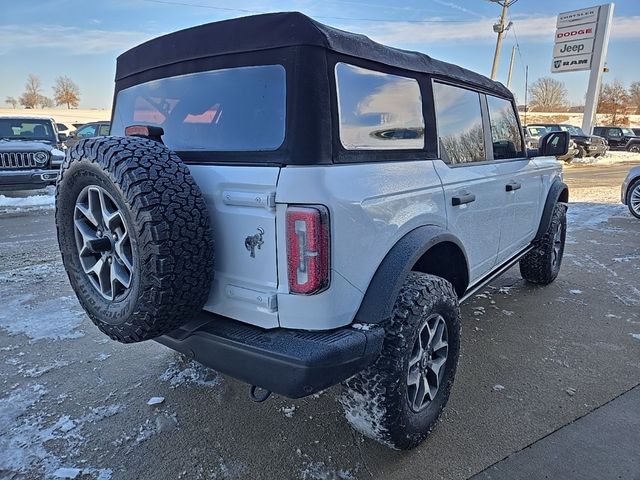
[338,272,460,450]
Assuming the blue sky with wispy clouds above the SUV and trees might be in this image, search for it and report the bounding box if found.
[5,0,640,108]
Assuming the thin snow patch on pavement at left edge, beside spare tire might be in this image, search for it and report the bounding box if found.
[0,294,84,343]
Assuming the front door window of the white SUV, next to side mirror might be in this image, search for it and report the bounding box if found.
[487,95,524,160]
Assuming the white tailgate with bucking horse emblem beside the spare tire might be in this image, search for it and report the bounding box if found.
[189,165,280,328]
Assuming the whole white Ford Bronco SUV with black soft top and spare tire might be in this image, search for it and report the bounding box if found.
[56,13,569,449]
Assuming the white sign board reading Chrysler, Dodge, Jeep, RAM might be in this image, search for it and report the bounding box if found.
[551,7,601,73]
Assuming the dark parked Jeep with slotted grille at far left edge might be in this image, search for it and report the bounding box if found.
[0,116,64,190]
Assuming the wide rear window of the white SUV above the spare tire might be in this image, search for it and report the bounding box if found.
[111,65,286,152]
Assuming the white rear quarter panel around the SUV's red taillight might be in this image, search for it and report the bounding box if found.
[276,160,446,330]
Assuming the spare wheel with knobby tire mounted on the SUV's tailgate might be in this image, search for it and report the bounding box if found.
[56,137,213,343]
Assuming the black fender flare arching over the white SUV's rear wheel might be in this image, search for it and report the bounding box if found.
[354,225,469,323]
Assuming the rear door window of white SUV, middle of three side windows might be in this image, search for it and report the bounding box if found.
[433,82,486,164]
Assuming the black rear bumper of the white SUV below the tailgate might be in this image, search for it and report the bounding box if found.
[156,312,384,398]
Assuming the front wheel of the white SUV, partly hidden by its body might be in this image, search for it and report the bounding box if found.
[520,203,567,285]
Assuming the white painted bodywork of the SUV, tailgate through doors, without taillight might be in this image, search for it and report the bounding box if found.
[189,158,561,330]
